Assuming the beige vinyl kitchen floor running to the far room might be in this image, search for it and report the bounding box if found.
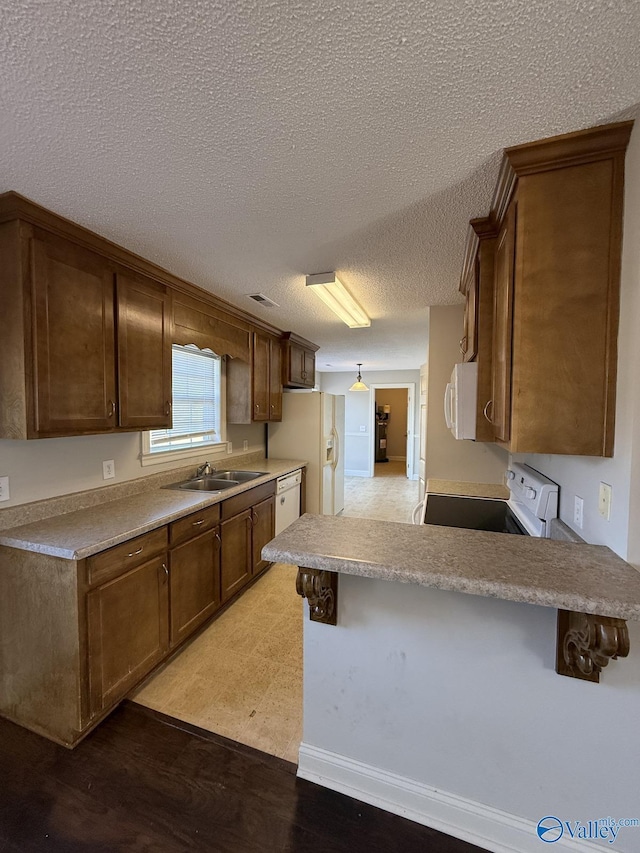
[129,462,418,763]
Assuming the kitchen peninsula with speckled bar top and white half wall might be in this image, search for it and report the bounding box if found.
[263,515,640,851]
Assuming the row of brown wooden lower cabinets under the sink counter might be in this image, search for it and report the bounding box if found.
[0,481,275,746]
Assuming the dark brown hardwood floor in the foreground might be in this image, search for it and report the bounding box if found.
[0,703,479,853]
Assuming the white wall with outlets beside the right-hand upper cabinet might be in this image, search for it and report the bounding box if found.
[515,124,640,565]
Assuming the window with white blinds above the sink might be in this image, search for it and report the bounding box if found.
[142,344,223,462]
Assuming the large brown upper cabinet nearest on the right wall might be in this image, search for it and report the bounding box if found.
[482,122,633,456]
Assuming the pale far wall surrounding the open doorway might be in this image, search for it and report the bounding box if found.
[317,370,420,477]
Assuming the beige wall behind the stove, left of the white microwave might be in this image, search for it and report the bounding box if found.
[425,305,508,483]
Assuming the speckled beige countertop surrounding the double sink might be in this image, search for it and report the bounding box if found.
[0,459,306,560]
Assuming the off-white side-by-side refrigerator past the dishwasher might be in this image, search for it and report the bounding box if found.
[268,391,344,515]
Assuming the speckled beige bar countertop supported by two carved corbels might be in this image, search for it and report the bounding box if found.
[262,514,640,621]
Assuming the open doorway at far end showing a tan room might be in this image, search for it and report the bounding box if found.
[369,383,416,480]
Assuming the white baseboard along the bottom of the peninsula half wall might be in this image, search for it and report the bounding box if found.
[298,743,603,853]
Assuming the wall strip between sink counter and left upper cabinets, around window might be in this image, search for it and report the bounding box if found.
[0,424,264,511]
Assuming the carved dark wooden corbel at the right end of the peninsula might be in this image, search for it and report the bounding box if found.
[556,610,629,683]
